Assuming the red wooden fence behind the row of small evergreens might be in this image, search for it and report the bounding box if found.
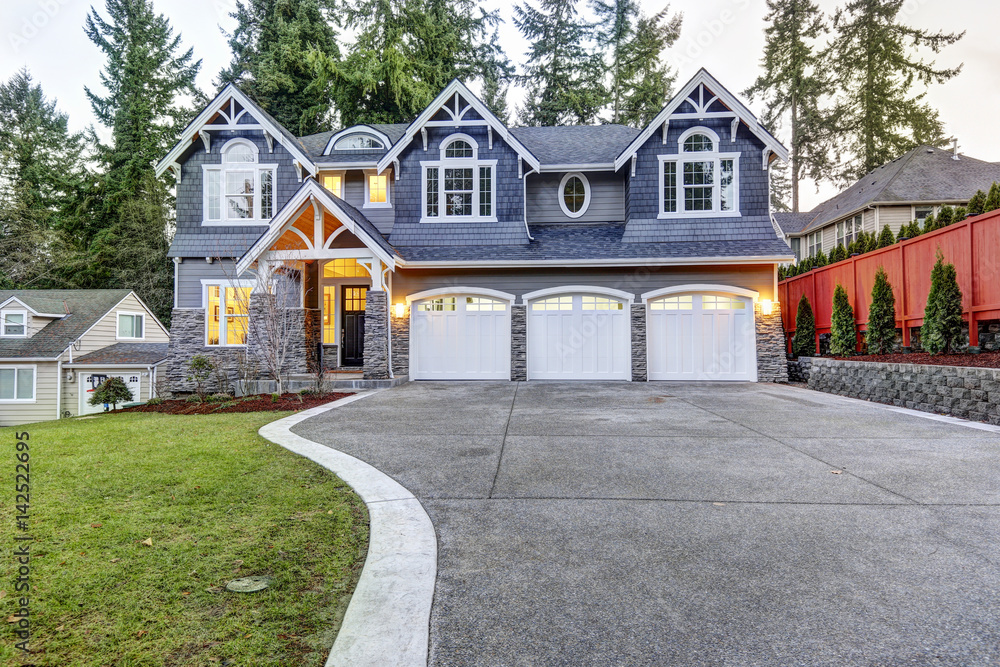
[778,210,1000,349]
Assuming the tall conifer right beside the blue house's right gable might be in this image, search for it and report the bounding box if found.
[744,0,832,212]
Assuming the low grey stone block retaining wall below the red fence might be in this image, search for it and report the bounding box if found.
[809,359,1000,425]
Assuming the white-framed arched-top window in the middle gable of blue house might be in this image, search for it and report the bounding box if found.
[420,134,497,222]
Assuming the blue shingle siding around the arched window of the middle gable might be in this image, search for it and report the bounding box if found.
[389,126,528,246]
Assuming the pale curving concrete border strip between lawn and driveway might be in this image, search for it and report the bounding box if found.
[258,391,437,667]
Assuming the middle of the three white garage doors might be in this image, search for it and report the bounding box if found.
[527,294,632,380]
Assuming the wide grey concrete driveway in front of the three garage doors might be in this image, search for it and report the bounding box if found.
[294,383,1000,666]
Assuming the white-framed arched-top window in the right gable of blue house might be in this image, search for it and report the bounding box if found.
[657,127,740,218]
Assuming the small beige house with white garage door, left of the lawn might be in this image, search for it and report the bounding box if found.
[0,289,169,426]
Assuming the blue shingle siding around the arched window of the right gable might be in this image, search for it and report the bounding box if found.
[622,119,776,243]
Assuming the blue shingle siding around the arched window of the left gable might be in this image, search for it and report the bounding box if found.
[169,128,300,257]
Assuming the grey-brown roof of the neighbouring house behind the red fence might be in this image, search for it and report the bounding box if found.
[775,146,1000,234]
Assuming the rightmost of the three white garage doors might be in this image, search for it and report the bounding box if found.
[646,294,757,381]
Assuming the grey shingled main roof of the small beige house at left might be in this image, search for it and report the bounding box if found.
[0,289,131,359]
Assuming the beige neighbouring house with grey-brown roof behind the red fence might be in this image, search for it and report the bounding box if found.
[772,146,1000,260]
